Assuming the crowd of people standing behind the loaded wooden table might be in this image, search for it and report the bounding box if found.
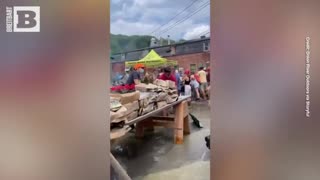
[121,65,210,100]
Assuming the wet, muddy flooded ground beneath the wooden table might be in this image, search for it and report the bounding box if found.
[112,102,210,180]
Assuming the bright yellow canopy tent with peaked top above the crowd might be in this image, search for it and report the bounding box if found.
[126,50,178,67]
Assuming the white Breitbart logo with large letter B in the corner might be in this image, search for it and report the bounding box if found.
[6,6,40,32]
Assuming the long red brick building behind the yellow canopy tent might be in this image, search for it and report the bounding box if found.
[111,37,210,76]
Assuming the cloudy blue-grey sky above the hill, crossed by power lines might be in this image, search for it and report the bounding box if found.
[111,0,210,40]
